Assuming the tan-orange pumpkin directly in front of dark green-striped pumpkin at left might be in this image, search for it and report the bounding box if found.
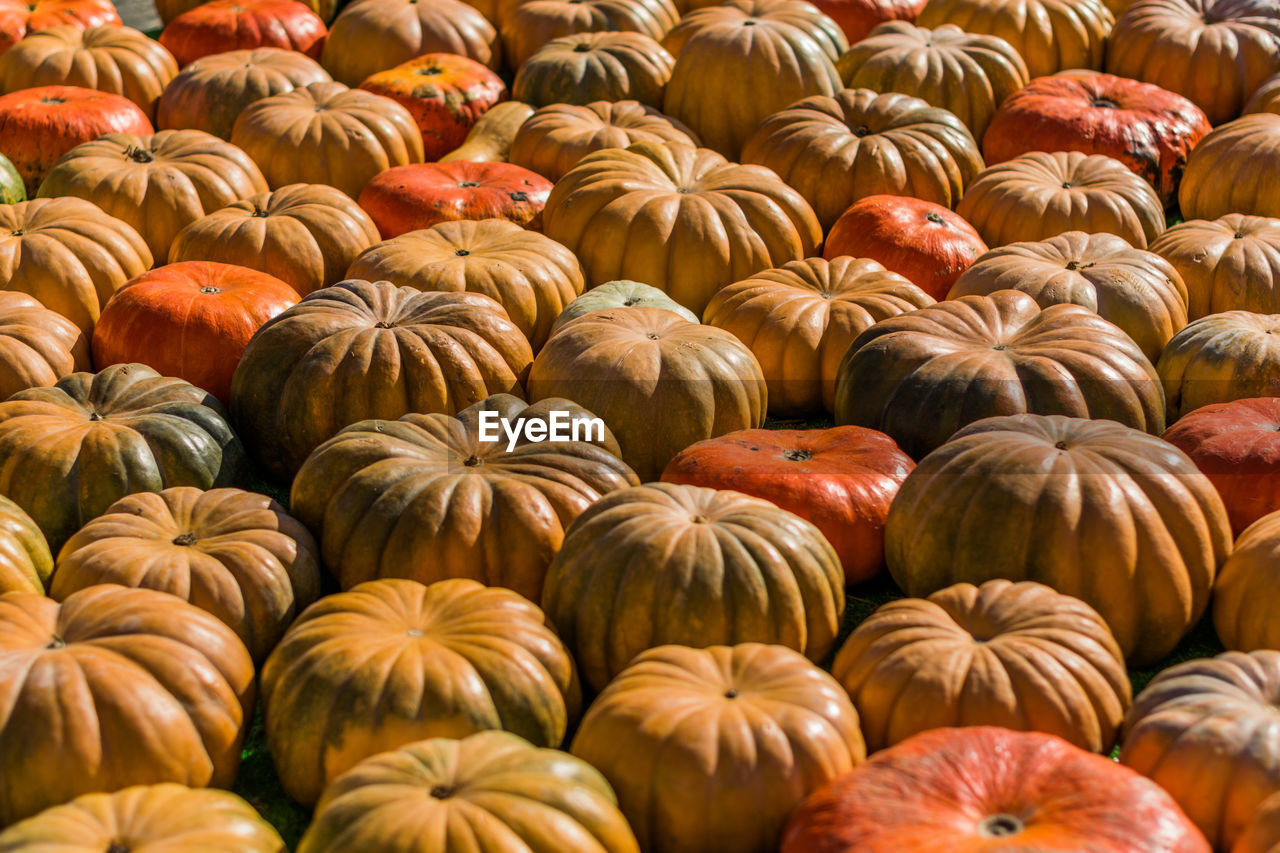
[53,487,320,655]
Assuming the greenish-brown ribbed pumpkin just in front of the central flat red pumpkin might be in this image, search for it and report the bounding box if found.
[541,483,845,690]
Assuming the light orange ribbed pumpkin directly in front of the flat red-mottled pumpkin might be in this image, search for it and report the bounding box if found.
[347,219,582,351]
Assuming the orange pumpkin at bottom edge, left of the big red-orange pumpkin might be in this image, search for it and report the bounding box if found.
[572,643,867,853]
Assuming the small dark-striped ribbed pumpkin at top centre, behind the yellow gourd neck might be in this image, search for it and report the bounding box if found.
[512,32,676,109]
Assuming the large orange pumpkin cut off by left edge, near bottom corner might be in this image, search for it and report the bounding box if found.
[0,584,253,824]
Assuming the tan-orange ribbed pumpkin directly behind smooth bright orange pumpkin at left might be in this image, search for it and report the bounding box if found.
[169,183,378,296]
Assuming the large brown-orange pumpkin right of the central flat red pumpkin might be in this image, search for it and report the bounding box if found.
[884,415,1231,666]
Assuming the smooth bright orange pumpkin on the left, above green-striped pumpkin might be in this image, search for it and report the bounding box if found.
[93,261,298,402]
